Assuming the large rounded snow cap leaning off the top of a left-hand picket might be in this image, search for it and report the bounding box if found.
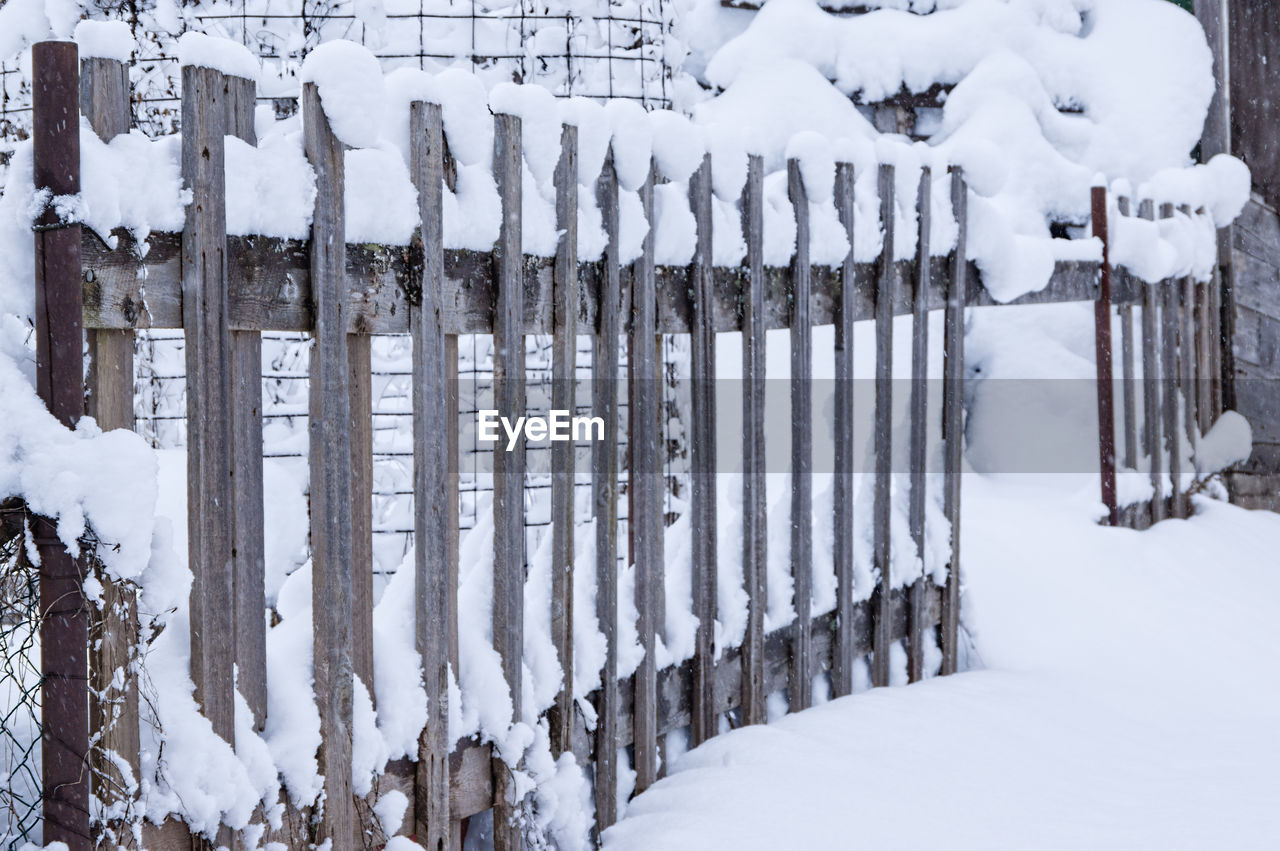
[299,36,387,147]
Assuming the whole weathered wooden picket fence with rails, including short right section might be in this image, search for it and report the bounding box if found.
[24,38,1220,848]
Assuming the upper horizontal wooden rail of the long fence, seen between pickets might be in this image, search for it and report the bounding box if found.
[83,229,1121,335]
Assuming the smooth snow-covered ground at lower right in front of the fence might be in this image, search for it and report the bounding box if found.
[604,475,1280,851]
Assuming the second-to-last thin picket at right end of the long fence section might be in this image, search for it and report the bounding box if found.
[906,166,933,682]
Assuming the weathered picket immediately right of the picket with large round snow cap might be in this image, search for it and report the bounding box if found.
[408,101,460,851]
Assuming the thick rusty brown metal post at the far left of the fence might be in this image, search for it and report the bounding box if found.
[31,41,92,851]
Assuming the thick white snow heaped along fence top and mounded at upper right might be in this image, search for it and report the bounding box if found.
[0,0,1248,314]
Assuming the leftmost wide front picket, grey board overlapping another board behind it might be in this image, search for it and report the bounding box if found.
[182,67,238,808]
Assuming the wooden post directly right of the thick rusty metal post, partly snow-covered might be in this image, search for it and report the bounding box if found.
[81,51,141,829]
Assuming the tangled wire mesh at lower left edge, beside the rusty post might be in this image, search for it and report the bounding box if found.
[0,504,41,851]
